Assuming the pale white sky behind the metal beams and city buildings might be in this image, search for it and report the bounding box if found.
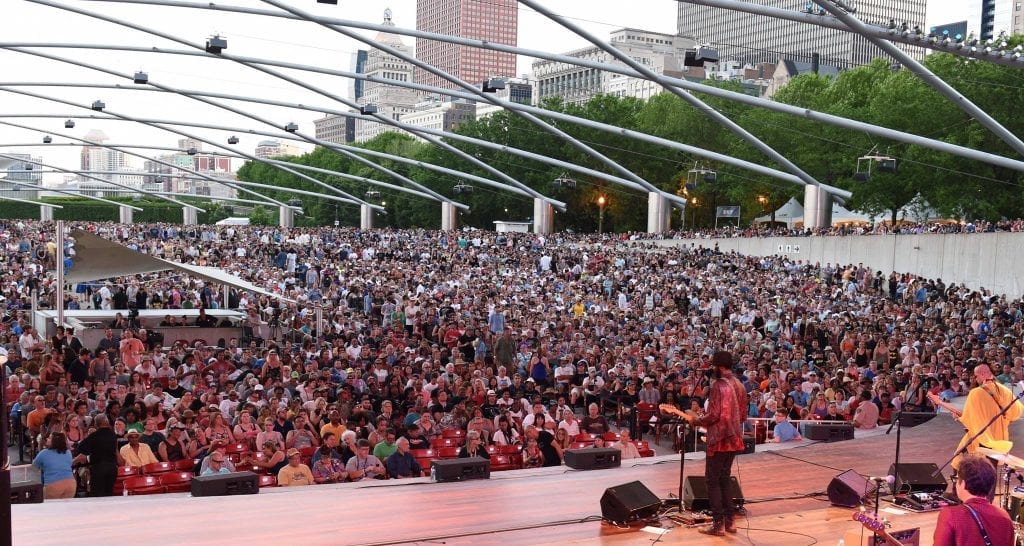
[0,0,966,182]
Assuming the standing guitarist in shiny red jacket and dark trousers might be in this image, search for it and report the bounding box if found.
[662,350,746,537]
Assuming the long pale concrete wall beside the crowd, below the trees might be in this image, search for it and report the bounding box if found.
[656,233,1024,298]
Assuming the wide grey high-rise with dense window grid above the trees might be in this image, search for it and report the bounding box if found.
[677,0,933,68]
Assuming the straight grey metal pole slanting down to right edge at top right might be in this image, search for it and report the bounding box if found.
[814,0,1024,154]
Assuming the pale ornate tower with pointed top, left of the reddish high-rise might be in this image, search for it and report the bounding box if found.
[355,9,423,142]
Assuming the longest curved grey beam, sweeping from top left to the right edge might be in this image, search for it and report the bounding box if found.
[64,0,1024,171]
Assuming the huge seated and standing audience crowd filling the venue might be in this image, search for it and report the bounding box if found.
[0,221,1024,496]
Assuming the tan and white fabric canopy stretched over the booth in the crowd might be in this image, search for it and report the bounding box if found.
[65,229,293,302]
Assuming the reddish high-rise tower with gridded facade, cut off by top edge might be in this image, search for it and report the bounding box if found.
[416,0,519,89]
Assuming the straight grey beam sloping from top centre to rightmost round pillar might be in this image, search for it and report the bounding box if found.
[520,0,820,193]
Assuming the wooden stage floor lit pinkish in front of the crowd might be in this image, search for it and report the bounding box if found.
[13,415,1024,546]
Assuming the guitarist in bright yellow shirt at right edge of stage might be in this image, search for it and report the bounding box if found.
[928,364,1024,469]
